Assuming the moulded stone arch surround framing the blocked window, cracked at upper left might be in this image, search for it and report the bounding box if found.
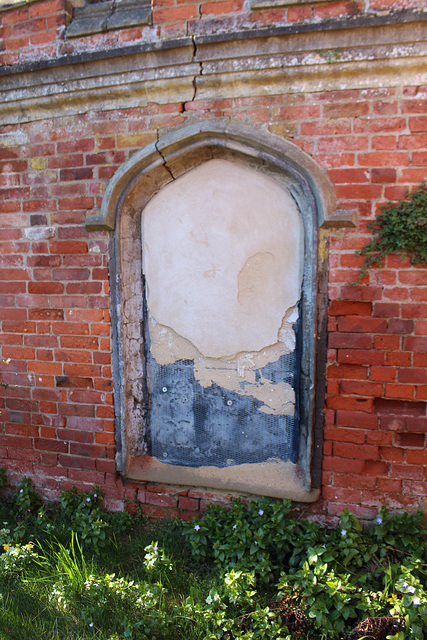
[86,121,349,502]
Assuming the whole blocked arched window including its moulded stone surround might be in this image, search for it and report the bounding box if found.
[87,121,344,501]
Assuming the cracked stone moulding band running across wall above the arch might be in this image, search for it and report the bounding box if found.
[0,11,427,125]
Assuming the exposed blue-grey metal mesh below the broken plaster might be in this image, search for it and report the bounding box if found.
[146,324,299,467]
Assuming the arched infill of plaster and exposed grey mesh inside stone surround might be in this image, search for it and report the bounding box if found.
[141,159,304,476]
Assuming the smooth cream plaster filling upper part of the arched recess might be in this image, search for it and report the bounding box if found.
[142,160,303,361]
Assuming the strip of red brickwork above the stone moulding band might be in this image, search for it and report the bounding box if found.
[0,0,426,65]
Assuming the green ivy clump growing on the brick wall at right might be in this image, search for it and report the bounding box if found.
[354,181,427,284]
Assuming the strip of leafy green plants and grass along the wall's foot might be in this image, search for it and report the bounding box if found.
[0,472,427,640]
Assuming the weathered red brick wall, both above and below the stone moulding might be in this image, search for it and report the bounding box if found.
[0,0,427,517]
